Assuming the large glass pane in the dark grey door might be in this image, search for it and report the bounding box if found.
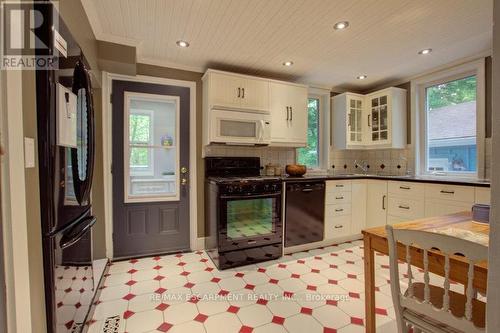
[125,95,179,202]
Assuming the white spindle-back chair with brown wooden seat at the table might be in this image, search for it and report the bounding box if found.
[386,225,488,333]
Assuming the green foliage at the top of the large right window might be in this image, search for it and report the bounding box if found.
[427,76,476,110]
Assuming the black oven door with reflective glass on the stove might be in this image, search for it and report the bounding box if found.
[218,193,283,252]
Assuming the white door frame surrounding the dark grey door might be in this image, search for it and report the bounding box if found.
[102,71,197,259]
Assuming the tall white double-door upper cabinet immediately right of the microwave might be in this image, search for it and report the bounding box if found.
[270,81,308,147]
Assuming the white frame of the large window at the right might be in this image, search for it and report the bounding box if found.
[411,58,486,179]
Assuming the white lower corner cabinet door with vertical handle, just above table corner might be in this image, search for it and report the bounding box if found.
[366,180,387,228]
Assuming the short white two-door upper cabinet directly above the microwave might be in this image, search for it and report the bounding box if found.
[204,70,269,112]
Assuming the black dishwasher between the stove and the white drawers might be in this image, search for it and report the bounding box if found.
[285,181,325,247]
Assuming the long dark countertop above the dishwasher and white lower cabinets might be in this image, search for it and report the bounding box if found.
[283,174,490,187]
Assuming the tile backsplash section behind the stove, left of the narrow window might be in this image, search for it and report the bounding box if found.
[204,145,295,168]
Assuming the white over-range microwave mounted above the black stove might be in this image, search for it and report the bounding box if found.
[210,109,271,145]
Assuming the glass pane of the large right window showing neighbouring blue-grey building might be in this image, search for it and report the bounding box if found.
[425,75,477,173]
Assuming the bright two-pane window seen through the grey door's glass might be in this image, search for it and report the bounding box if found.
[129,109,153,175]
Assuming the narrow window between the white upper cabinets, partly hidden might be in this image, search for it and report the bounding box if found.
[297,98,320,169]
